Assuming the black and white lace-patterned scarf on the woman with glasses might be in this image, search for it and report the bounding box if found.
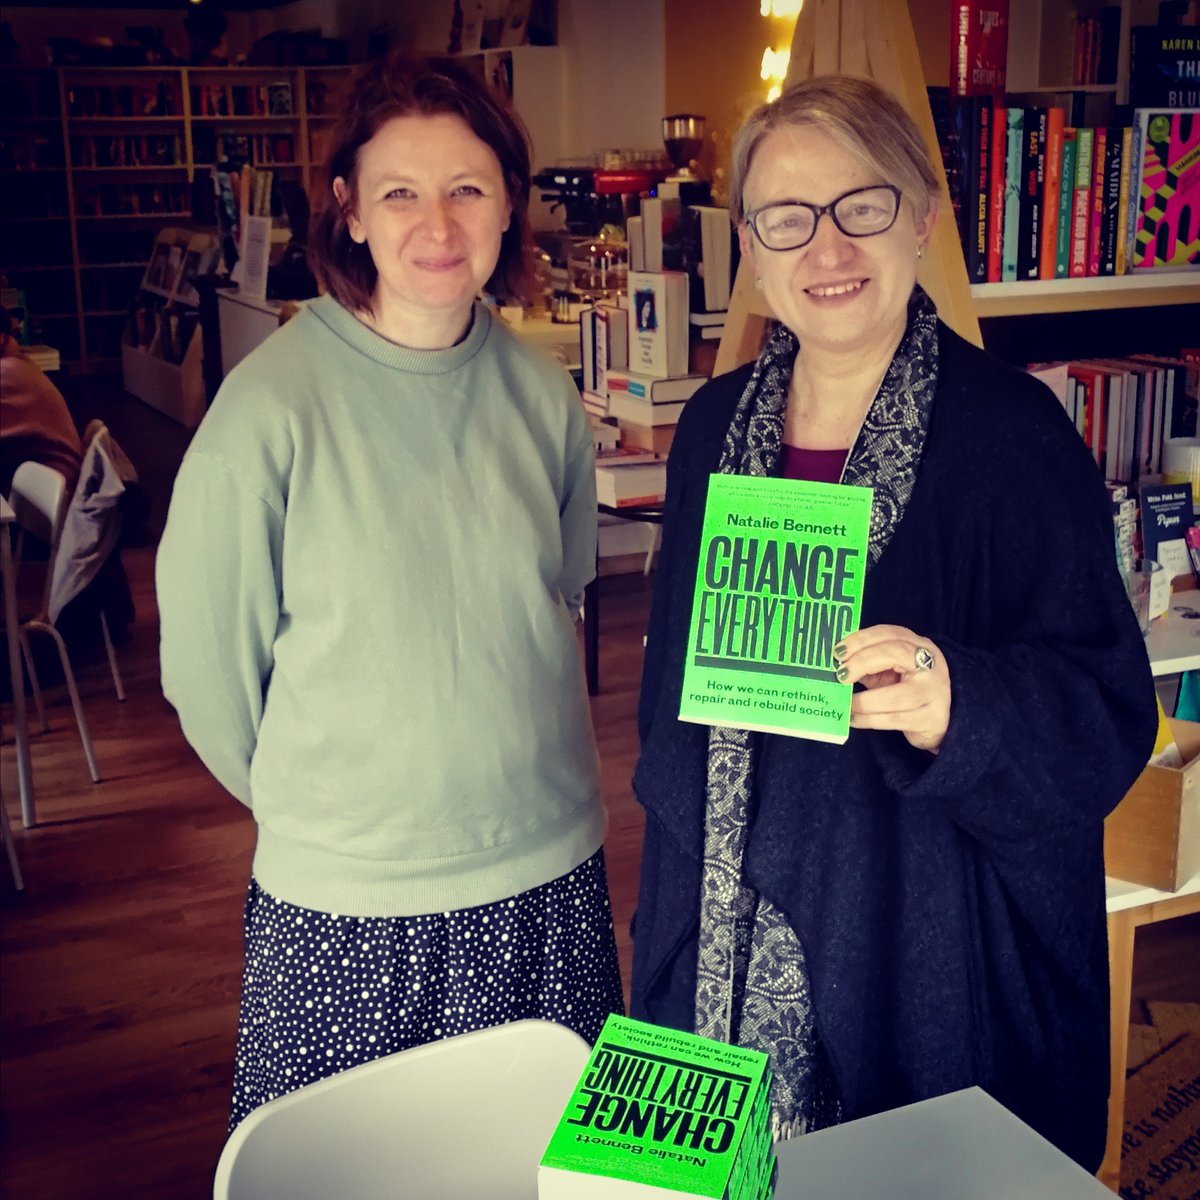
[696,287,937,1141]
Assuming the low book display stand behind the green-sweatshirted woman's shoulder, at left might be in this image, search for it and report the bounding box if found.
[121,228,217,428]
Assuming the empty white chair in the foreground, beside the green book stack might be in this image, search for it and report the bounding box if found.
[212,1020,589,1200]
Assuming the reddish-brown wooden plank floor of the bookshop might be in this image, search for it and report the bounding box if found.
[0,376,1200,1200]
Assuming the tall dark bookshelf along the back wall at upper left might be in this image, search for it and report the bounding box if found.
[0,67,350,370]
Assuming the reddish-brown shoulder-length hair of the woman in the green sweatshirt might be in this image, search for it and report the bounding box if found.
[308,53,533,312]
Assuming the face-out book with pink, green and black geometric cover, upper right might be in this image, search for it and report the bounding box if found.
[1132,108,1200,270]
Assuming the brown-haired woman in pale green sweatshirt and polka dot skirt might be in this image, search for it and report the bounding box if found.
[158,51,622,1126]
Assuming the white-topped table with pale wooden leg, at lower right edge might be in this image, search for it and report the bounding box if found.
[1098,875,1200,1192]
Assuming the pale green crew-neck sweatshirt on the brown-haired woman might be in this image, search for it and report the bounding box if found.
[157,296,604,916]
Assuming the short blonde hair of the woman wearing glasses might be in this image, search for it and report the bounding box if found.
[730,74,938,224]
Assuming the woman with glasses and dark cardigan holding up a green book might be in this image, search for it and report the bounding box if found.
[632,77,1156,1169]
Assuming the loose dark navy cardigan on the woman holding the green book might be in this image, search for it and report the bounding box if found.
[632,325,1156,1169]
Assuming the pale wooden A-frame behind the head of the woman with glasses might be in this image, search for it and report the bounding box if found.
[713,0,983,374]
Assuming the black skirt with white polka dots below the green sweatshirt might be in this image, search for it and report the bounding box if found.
[229,850,624,1130]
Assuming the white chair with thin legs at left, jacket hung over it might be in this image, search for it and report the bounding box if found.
[8,462,100,784]
